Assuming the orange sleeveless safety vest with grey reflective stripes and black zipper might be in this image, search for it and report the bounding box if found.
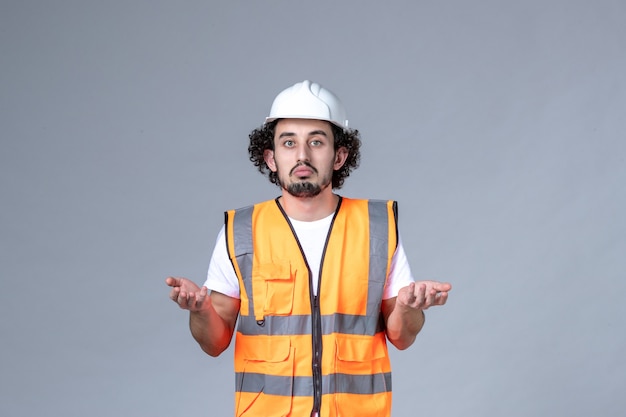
[226,198,398,417]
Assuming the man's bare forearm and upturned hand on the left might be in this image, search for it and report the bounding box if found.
[165,277,240,356]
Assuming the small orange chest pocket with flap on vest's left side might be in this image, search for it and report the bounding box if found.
[259,261,295,316]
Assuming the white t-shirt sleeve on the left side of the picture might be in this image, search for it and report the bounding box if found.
[204,226,240,299]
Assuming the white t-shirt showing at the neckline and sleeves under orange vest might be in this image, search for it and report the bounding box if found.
[204,214,414,300]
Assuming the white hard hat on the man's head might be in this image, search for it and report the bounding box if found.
[265,80,348,129]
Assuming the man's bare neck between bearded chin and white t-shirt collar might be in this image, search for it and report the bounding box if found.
[278,189,339,222]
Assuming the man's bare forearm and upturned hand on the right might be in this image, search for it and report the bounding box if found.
[382,281,452,350]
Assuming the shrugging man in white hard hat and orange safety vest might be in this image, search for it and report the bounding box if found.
[166,81,451,417]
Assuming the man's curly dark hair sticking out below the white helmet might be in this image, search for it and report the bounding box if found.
[248,119,361,189]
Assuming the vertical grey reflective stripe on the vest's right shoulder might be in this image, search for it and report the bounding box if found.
[366,200,389,317]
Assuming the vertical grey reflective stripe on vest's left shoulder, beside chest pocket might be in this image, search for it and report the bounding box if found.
[226,206,254,317]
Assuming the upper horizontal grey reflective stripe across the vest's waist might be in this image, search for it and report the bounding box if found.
[238,313,384,336]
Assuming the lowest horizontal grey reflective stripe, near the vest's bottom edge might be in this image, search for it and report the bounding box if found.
[235,372,391,397]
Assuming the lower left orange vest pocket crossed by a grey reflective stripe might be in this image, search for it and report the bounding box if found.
[235,336,294,417]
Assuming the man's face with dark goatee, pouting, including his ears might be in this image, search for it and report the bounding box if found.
[265,119,347,197]
